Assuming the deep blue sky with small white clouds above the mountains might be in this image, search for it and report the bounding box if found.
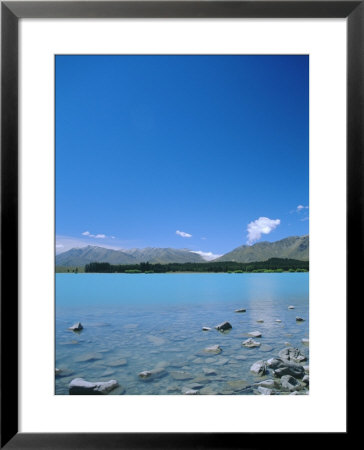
[56,55,309,255]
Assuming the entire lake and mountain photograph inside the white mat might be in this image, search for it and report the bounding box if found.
[55,54,313,401]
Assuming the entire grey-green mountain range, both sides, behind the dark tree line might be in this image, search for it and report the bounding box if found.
[56,235,309,267]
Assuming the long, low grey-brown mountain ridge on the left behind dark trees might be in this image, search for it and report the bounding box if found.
[56,245,205,267]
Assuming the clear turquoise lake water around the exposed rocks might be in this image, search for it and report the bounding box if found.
[55,273,309,395]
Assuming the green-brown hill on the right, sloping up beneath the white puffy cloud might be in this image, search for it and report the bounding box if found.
[214,235,309,262]
